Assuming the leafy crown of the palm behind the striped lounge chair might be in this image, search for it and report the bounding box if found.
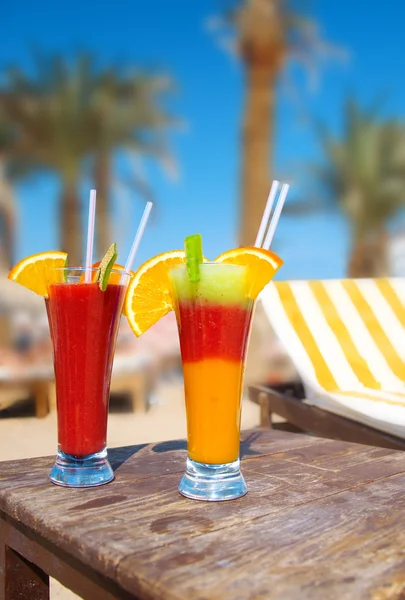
[310,97,405,232]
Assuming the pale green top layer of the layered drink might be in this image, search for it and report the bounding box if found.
[169,263,248,304]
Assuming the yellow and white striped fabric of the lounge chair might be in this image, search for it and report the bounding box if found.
[260,279,405,438]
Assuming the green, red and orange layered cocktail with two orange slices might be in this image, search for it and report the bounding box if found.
[125,230,282,501]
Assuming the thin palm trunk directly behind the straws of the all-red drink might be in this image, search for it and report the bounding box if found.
[94,152,109,258]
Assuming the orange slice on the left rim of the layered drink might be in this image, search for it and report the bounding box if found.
[124,250,186,337]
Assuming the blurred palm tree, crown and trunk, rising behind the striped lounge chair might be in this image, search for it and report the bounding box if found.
[315,99,405,277]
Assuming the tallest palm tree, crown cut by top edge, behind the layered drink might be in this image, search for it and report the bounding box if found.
[210,0,326,245]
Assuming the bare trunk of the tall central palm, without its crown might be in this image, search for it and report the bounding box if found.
[239,64,276,246]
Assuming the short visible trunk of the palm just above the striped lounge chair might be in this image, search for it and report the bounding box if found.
[347,225,389,278]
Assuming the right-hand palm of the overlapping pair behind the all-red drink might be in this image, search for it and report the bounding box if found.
[92,71,174,253]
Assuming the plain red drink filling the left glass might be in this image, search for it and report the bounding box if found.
[47,283,125,456]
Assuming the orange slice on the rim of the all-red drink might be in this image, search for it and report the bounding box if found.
[8,250,67,298]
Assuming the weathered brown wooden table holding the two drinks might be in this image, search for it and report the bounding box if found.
[0,430,405,600]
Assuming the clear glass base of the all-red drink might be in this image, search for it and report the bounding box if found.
[49,448,114,487]
